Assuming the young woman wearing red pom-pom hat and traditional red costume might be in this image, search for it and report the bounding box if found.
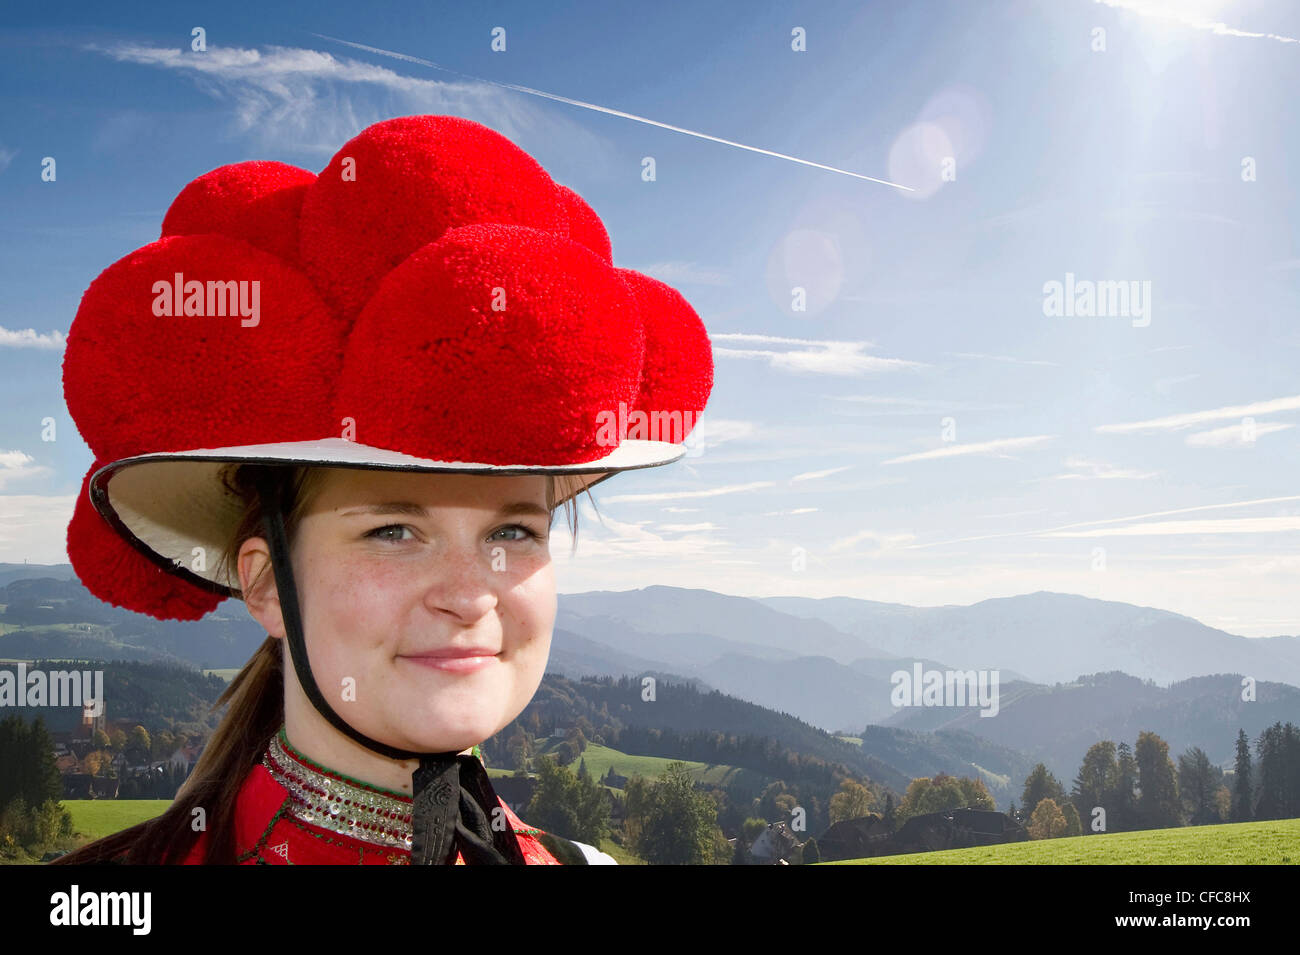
[48,111,712,864]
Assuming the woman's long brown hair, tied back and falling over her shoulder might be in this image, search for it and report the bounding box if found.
[52,464,594,865]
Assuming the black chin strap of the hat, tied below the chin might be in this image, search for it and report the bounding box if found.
[256,468,525,865]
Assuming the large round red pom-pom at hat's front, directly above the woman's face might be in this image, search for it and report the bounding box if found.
[334,225,645,464]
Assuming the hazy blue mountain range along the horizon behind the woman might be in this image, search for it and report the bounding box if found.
[0,564,1300,802]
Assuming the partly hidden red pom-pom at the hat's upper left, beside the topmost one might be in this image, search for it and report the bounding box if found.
[163,160,316,264]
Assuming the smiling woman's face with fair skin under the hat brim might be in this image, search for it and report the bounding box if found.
[244,468,556,752]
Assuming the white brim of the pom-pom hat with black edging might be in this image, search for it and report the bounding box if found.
[90,438,686,596]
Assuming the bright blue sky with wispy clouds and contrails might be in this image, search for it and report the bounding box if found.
[0,0,1300,635]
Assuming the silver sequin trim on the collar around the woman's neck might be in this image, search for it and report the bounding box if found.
[261,733,412,852]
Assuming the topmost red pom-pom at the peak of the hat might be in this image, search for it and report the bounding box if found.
[300,116,566,316]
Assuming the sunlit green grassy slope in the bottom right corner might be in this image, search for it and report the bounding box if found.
[824,819,1300,865]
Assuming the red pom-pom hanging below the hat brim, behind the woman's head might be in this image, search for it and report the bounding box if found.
[68,461,222,620]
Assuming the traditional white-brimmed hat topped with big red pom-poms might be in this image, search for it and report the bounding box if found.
[64,116,712,620]
